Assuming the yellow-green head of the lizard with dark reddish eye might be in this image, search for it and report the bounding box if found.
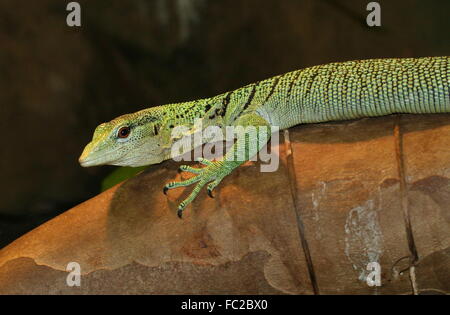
[79,109,167,167]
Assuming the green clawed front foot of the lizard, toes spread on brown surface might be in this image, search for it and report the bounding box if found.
[163,158,229,218]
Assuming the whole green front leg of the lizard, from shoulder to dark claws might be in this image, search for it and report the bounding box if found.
[163,112,271,218]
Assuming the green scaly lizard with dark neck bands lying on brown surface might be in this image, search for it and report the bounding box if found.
[79,56,450,217]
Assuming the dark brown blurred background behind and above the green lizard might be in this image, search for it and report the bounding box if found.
[0,0,450,248]
